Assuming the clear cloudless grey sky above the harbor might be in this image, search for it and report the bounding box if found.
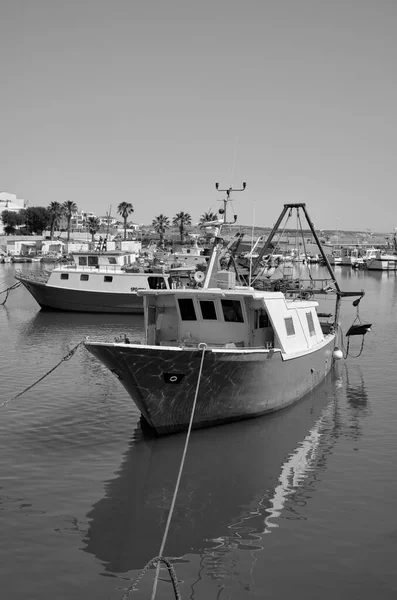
[0,0,397,232]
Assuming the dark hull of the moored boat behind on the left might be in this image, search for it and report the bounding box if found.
[19,278,143,314]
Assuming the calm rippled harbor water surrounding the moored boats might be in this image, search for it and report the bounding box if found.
[0,265,397,600]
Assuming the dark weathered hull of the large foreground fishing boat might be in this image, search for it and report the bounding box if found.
[86,335,335,434]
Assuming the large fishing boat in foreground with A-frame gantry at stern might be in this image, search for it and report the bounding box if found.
[85,195,363,434]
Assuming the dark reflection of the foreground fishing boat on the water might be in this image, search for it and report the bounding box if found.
[84,384,333,573]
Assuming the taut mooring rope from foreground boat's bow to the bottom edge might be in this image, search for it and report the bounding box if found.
[121,344,207,600]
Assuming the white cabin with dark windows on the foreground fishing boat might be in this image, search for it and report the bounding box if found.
[139,288,326,355]
